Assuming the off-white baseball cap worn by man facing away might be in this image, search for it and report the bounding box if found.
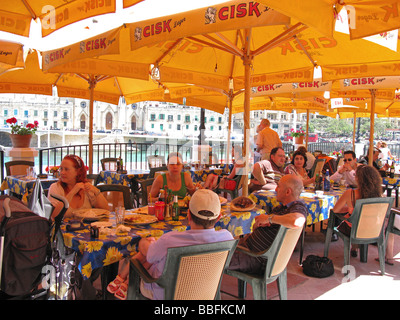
[189,189,221,220]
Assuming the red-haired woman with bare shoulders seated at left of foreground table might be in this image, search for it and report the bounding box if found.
[48,154,108,217]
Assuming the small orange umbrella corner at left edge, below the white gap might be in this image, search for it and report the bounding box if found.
[0,40,24,74]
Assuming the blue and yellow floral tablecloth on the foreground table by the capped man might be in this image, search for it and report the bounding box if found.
[61,205,265,279]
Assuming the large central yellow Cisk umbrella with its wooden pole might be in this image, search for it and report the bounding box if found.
[39,1,400,194]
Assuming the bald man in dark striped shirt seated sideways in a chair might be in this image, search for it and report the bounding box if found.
[229,174,308,274]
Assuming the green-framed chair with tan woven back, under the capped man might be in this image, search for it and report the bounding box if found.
[128,240,238,300]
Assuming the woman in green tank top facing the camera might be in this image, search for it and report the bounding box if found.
[150,152,195,199]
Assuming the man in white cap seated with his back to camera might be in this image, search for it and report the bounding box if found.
[135,189,233,300]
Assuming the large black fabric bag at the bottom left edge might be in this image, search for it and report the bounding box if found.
[0,196,51,296]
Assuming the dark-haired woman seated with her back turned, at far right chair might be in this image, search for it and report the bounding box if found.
[333,165,383,257]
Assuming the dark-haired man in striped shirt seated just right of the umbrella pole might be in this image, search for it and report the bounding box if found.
[249,147,286,193]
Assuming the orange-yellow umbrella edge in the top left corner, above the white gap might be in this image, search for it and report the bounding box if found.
[0,0,142,37]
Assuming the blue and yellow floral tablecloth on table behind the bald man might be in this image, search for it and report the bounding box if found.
[249,189,345,225]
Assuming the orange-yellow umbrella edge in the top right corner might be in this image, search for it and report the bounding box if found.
[260,0,400,39]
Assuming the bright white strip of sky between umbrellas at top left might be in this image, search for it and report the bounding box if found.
[0,0,228,51]
